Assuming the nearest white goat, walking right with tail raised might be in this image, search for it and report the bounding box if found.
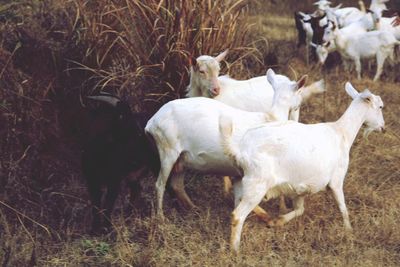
[220,82,384,251]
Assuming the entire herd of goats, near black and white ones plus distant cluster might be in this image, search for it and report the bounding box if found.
[82,1,390,252]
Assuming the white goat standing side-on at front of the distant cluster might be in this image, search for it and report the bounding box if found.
[326,22,400,81]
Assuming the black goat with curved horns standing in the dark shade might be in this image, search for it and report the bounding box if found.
[82,95,160,233]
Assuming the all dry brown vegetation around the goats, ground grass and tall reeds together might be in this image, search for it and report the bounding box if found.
[0,0,400,266]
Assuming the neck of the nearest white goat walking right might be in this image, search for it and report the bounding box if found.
[334,100,367,150]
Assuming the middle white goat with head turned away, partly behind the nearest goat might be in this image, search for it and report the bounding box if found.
[145,69,307,220]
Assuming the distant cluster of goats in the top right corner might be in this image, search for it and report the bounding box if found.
[295,0,400,81]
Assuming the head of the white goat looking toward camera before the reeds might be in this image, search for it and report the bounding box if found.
[188,50,228,97]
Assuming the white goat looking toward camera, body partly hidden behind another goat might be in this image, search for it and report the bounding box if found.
[186,50,325,121]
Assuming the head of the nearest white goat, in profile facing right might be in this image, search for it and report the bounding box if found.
[345,82,385,136]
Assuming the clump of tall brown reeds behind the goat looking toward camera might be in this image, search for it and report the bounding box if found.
[70,0,257,110]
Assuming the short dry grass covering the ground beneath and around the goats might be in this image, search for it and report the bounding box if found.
[0,0,400,266]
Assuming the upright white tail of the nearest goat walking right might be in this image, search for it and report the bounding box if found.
[219,115,240,166]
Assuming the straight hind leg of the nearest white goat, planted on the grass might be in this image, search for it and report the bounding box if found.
[230,176,267,252]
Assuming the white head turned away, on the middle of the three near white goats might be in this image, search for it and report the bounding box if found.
[267,69,308,120]
